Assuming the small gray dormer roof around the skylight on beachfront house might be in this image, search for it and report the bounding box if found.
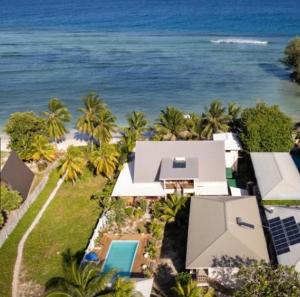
[159,158,199,180]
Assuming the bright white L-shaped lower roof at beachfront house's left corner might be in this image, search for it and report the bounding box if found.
[112,161,165,197]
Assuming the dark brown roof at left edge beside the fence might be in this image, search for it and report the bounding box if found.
[0,151,34,199]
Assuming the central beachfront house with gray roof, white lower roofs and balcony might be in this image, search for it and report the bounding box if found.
[112,141,228,197]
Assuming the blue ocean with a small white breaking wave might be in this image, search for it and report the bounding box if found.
[0,0,300,127]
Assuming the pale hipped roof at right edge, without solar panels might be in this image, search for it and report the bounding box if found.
[251,153,300,200]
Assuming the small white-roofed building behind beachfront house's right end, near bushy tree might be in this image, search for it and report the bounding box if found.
[213,132,242,170]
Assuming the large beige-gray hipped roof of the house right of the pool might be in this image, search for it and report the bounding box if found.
[186,196,269,269]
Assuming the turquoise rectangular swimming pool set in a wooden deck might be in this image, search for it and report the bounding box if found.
[102,240,139,277]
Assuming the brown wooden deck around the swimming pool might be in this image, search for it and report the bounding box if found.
[95,234,151,277]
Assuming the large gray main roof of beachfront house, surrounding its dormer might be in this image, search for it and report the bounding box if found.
[134,141,226,183]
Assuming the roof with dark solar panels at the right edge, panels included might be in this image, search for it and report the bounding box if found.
[265,206,300,272]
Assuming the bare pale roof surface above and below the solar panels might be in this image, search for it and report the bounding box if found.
[265,206,300,272]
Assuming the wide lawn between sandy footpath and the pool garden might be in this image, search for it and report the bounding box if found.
[24,171,105,285]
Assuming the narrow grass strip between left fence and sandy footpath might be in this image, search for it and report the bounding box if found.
[0,170,59,297]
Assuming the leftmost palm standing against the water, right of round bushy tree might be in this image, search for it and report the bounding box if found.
[43,98,71,142]
